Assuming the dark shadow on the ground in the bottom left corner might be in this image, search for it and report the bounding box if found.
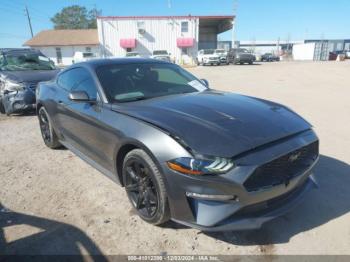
[0,203,108,261]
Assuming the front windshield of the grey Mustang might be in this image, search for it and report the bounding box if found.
[96,63,207,102]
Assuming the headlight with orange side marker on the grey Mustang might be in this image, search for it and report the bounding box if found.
[167,157,234,175]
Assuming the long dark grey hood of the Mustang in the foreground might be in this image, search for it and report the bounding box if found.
[112,91,311,157]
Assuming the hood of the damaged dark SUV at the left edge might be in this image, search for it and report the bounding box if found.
[0,69,59,83]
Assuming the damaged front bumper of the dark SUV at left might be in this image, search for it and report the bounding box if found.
[1,88,35,114]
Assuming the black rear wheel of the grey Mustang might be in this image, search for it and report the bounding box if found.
[38,107,61,149]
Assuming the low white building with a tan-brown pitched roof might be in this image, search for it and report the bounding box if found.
[24,29,100,65]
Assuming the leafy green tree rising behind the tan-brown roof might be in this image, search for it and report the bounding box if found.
[51,5,101,29]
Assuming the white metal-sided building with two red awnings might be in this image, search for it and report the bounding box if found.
[97,16,234,63]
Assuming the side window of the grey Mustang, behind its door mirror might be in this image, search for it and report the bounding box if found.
[57,68,97,99]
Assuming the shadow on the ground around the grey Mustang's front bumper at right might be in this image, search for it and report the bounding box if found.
[205,155,350,246]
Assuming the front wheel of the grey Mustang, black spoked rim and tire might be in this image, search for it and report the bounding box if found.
[123,149,170,225]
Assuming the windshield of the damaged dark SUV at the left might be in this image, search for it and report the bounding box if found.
[0,53,55,71]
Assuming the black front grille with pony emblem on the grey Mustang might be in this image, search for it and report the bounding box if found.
[243,141,318,192]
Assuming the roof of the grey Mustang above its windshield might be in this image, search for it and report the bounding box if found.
[70,58,169,69]
